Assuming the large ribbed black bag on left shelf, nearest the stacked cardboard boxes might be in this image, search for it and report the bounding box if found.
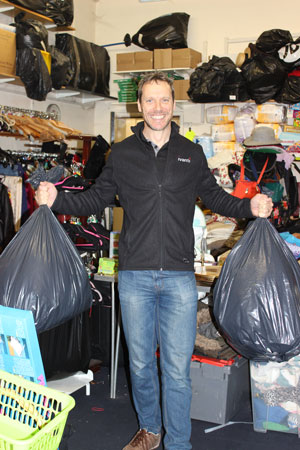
[55,33,110,96]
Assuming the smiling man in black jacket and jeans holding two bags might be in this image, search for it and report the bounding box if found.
[37,73,272,450]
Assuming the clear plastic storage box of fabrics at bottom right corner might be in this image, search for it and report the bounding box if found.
[250,356,300,437]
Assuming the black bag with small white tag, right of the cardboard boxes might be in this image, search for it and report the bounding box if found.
[187,55,249,103]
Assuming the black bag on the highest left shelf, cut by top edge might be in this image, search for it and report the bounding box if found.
[11,0,74,26]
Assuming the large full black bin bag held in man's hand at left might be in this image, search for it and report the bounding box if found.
[0,205,92,333]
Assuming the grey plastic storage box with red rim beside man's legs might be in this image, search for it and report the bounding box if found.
[190,356,250,424]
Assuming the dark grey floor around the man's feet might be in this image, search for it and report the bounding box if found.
[60,366,300,450]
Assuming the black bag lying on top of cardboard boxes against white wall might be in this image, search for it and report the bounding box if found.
[132,12,190,50]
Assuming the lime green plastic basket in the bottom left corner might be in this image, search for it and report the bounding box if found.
[0,370,75,450]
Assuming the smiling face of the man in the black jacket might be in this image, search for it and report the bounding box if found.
[138,81,175,131]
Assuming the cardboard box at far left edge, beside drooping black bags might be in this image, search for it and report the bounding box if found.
[0,28,16,76]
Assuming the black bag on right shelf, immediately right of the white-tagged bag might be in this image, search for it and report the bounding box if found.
[241,53,286,104]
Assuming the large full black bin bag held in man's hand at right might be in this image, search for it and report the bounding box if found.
[213,218,300,362]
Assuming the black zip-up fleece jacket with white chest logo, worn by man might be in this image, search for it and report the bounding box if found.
[52,122,253,271]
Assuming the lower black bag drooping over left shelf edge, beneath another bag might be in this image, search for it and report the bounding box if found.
[16,48,52,101]
